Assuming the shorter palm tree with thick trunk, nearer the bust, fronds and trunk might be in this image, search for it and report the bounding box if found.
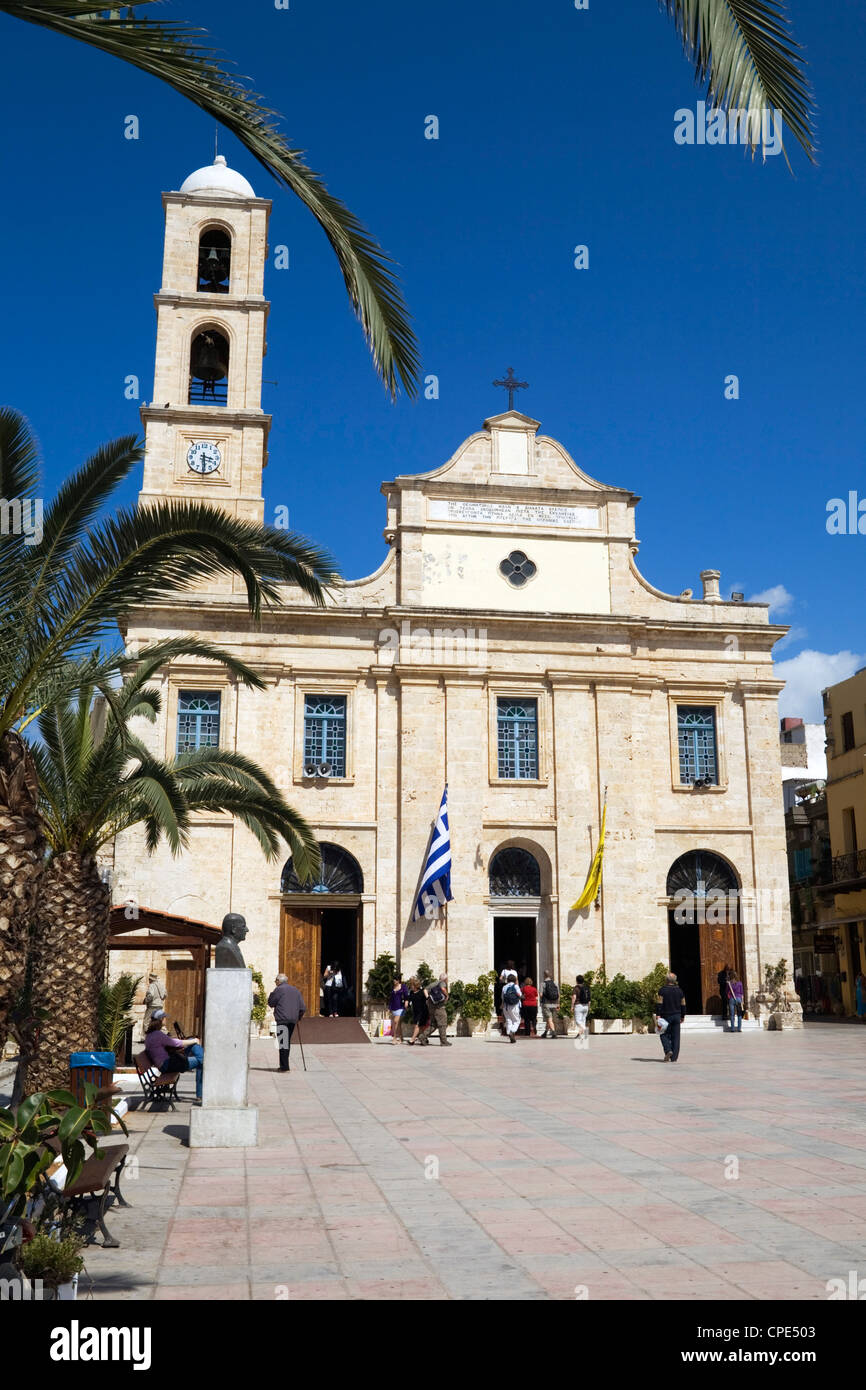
[27,638,325,1091]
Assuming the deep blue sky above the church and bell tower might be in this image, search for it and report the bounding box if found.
[0,0,866,719]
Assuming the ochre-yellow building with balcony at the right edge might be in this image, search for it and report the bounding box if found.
[820,667,866,1015]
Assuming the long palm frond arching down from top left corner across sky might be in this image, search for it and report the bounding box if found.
[0,0,418,398]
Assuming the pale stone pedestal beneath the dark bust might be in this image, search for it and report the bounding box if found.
[189,969,259,1148]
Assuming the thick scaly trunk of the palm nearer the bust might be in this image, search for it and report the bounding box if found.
[25,851,111,1094]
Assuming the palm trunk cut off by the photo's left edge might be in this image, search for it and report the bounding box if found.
[0,734,44,1055]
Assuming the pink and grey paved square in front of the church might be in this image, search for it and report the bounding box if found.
[85,1026,866,1301]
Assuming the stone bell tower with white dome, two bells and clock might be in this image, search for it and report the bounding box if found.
[139,154,271,521]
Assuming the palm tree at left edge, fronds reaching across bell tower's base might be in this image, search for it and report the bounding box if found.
[0,407,336,1049]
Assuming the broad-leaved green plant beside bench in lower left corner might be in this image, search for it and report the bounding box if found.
[0,1081,126,1219]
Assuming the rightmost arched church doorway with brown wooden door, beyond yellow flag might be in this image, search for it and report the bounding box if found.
[667,849,748,1015]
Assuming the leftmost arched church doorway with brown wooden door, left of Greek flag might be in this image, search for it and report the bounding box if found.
[279,842,364,1017]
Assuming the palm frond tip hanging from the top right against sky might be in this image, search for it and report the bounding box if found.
[659,0,815,163]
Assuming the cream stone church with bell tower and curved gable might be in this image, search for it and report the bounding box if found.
[109,164,792,1012]
